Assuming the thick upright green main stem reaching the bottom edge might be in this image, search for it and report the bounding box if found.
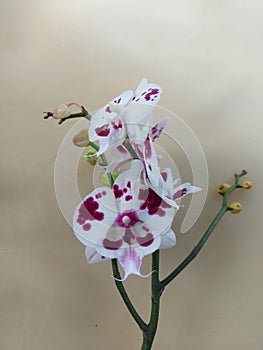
[141,250,160,350]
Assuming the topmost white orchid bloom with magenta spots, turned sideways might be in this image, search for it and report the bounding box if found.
[89,79,162,155]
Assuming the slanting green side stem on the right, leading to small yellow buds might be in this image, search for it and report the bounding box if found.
[159,170,247,295]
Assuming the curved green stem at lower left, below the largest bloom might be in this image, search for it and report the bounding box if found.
[111,259,147,332]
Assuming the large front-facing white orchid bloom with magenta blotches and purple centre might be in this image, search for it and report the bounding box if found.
[73,163,176,279]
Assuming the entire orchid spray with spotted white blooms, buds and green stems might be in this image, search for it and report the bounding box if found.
[44,79,251,350]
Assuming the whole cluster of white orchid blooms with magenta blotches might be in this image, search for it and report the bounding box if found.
[50,79,200,279]
